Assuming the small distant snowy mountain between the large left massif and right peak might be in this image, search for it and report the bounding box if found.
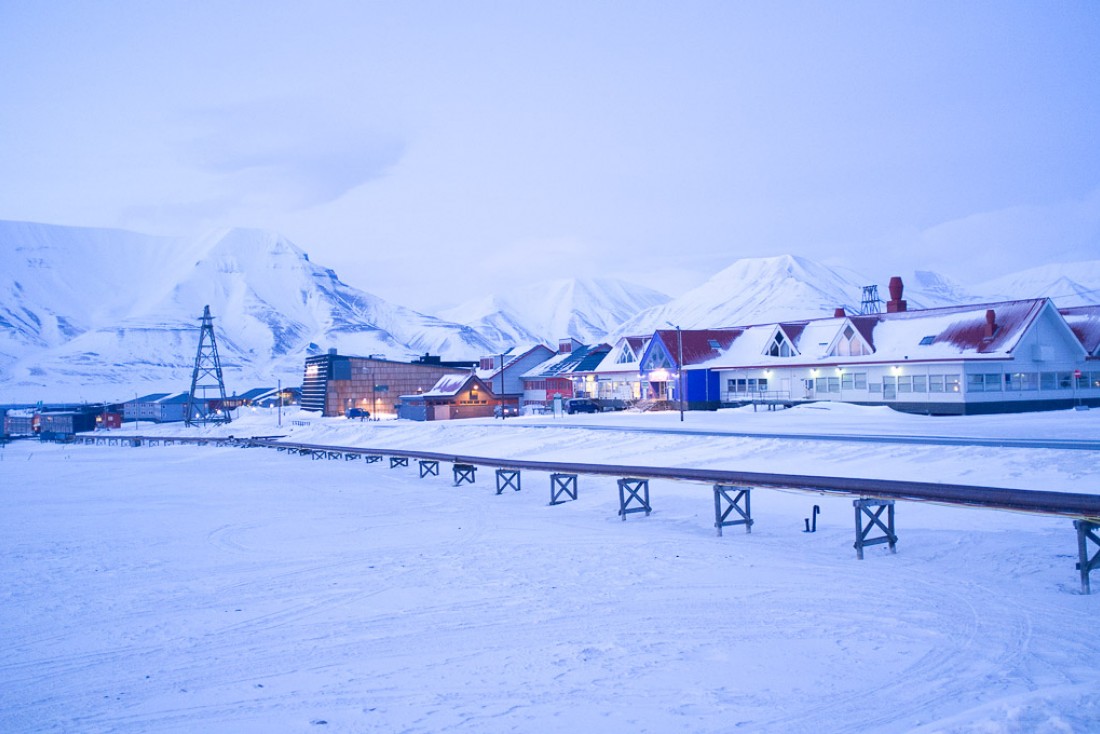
[439,278,669,344]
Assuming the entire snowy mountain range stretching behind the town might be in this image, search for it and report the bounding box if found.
[0,221,1100,404]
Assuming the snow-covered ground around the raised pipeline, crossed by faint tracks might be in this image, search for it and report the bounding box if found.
[0,406,1100,734]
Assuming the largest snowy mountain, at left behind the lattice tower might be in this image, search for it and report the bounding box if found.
[0,222,496,402]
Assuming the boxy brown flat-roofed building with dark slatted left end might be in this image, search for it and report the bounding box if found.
[301,349,473,416]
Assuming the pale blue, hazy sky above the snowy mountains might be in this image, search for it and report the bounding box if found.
[0,0,1100,309]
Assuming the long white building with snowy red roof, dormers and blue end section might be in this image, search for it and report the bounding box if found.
[664,278,1100,415]
